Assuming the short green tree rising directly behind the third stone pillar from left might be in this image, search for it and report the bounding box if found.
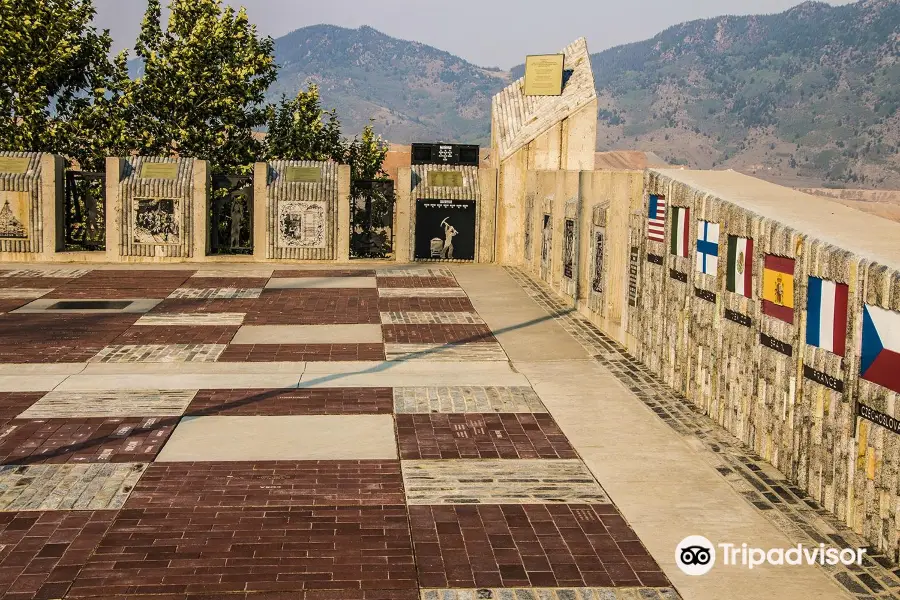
[266,84,347,162]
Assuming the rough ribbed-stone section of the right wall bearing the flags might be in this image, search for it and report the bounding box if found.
[629,166,900,556]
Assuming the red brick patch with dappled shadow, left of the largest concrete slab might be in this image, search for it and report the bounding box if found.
[0,417,178,465]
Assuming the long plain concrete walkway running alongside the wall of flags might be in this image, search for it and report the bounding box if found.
[454,266,852,600]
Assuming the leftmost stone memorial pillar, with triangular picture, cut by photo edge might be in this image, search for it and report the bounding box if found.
[0,152,63,260]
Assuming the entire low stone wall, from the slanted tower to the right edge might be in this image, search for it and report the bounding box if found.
[522,170,900,560]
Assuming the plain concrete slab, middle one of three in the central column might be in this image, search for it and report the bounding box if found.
[231,324,382,344]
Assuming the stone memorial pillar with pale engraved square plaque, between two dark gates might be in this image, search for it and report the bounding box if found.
[265,161,349,260]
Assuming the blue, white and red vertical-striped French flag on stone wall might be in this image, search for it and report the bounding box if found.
[806,277,850,356]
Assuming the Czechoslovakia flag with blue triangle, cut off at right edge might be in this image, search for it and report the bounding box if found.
[859,304,900,392]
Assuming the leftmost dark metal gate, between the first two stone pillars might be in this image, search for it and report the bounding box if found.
[63,171,106,251]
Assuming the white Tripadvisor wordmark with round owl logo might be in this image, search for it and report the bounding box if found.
[675,535,866,575]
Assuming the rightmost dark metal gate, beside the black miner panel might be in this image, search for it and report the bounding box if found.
[350,179,394,258]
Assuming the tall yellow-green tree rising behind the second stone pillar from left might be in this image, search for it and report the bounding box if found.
[125,0,277,172]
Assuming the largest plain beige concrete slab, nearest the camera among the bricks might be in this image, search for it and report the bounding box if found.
[157,415,397,462]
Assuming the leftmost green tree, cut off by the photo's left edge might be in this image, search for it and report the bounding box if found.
[0,0,124,165]
